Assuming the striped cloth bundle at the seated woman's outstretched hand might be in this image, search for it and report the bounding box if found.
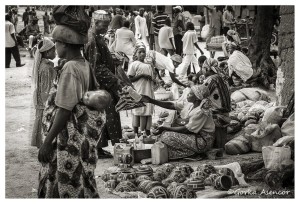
[116,86,145,112]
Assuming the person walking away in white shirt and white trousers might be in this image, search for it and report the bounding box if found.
[177,22,204,76]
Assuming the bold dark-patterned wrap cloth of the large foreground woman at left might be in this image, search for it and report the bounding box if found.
[38,66,106,198]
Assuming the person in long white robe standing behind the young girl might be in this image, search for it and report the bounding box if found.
[134,8,149,50]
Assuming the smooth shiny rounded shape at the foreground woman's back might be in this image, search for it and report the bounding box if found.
[83,90,111,111]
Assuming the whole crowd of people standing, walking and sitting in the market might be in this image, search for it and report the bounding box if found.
[6,6,253,197]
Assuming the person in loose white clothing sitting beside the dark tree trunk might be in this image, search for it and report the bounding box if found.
[227,43,253,85]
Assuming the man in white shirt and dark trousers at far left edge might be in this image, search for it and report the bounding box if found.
[5,14,25,68]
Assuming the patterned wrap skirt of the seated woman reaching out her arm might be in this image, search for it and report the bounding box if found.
[160,131,214,160]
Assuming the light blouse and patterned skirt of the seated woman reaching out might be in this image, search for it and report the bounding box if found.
[160,102,215,159]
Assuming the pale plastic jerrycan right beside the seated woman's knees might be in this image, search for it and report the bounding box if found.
[151,142,168,164]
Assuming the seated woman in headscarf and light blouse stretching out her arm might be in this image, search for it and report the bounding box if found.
[142,85,215,159]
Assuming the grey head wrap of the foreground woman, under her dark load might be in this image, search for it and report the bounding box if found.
[52,25,88,45]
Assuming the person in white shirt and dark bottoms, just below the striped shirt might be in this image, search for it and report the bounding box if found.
[158,18,175,56]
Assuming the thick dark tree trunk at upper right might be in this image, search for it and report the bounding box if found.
[248,6,276,88]
